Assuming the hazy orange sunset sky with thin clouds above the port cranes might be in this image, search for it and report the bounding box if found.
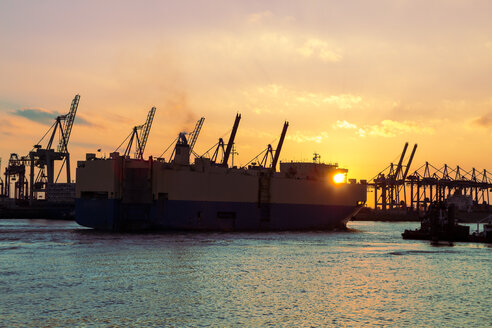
[0,0,492,178]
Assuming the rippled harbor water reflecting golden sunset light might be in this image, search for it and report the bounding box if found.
[0,220,492,327]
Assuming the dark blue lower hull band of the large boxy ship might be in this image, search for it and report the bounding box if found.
[76,199,360,231]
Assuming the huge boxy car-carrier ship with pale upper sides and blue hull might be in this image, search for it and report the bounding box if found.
[75,115,366,231]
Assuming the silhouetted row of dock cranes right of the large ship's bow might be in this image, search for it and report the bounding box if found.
[368,143,492,214]
